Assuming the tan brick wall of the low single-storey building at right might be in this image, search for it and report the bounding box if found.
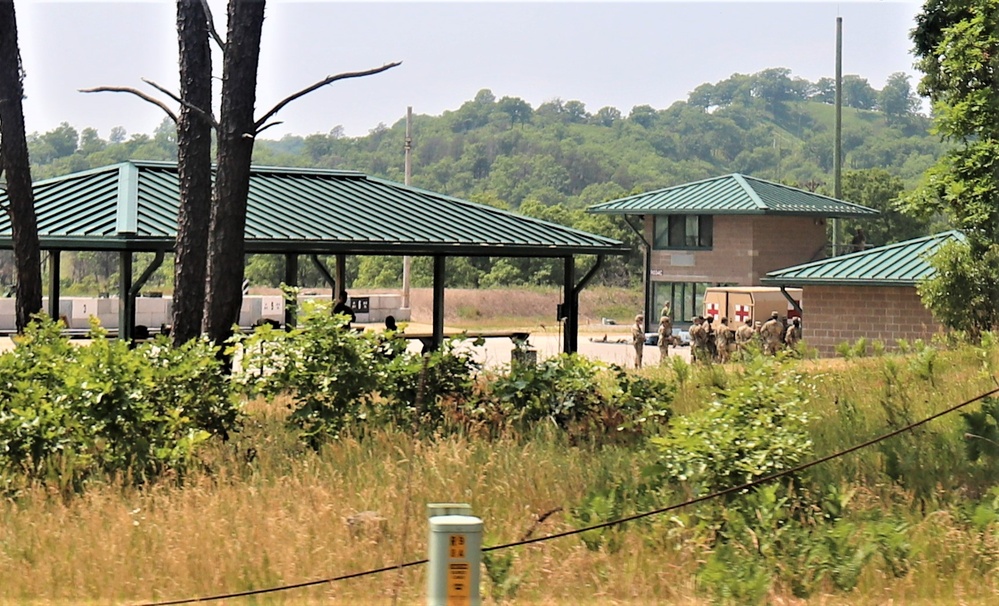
[801,286,942,356]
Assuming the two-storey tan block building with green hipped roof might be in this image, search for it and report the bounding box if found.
[588,174,877,325]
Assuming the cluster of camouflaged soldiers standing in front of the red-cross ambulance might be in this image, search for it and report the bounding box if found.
[690,311,801,363]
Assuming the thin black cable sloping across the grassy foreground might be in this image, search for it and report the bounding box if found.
[137,387,999,606]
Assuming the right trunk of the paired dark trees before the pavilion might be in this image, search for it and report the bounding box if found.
[204,0,264,344]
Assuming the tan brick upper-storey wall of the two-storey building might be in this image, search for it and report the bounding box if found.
[644,215,826,286]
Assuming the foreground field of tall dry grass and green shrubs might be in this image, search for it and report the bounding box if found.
[0,312,999,605]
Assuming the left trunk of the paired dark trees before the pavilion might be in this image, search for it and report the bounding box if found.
[171,0,212,345]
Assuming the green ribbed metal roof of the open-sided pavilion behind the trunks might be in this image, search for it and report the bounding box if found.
[0,161,629,256]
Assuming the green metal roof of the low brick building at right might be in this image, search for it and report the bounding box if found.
[761,231,964,286]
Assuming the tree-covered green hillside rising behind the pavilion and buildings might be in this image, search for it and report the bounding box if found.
[19,68,947,288]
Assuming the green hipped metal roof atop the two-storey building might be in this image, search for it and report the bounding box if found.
[587,174,878,217]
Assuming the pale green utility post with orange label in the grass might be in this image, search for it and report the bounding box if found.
[427,503,482,606]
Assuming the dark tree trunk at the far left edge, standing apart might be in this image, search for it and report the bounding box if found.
[0,0,42,332]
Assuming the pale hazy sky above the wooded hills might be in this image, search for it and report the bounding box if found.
[16,0,921,138]
